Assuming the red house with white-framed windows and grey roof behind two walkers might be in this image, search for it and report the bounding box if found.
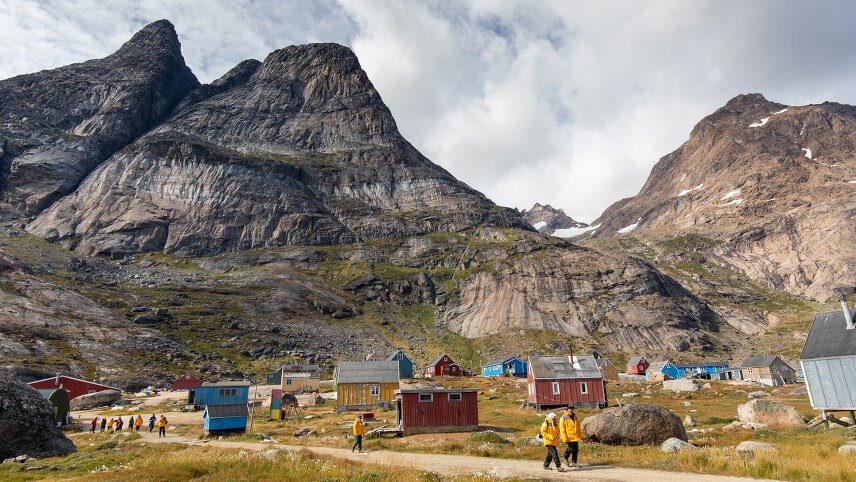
[526,355,607,409]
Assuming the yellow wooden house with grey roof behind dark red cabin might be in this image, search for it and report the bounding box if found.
[334,361,398,412]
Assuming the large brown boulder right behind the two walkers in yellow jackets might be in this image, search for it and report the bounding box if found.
[582,405,687,445]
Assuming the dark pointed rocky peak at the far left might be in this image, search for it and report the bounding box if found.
[0,21,199,219]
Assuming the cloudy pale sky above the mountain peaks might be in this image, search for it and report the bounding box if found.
[0,0,856,222]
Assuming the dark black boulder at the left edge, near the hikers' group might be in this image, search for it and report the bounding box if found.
[0,375,77,460]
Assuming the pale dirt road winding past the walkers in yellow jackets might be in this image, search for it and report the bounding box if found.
[142,433,776,482]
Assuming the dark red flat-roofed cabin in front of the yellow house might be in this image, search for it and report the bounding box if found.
[395,388,479,435]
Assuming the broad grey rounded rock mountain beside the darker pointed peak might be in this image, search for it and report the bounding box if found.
[29,44,531,256]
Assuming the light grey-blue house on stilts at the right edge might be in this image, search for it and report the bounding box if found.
[800,301,856,418]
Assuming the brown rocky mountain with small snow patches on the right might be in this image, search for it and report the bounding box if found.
[589,94,856,301]
